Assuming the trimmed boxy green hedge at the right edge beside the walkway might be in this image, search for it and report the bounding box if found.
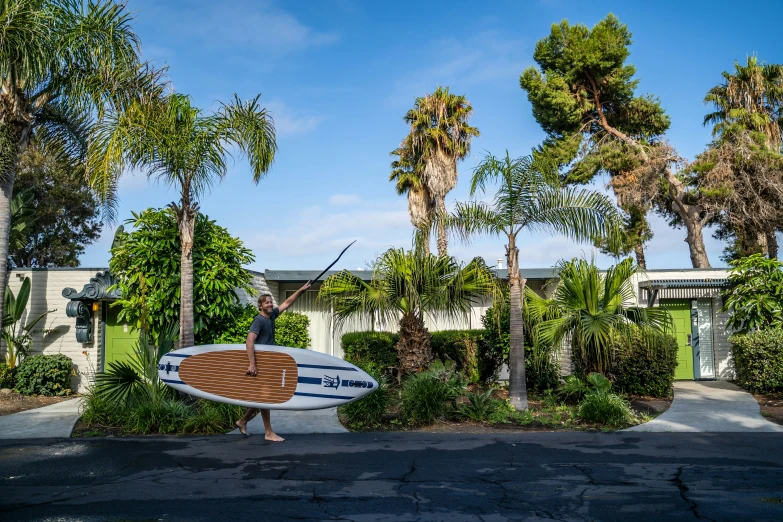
[729,330,783,393]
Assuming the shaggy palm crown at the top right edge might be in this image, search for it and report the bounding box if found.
[704,56,783,150]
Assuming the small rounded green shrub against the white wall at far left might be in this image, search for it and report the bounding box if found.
[14,353,73,395]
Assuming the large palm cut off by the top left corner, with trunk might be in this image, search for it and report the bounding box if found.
[0,0,160,324]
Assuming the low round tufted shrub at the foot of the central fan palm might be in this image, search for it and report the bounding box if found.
[400,372,453,424]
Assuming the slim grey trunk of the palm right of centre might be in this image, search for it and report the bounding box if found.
[506,237,528,411]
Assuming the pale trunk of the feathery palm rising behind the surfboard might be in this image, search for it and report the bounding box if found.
[177,197,198,348]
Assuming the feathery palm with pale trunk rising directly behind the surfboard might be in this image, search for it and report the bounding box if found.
[90,93,277,347]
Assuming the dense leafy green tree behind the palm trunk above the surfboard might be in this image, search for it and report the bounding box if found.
[109,205,255,343]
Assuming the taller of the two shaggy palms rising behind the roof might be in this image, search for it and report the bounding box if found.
[403,87,479,256]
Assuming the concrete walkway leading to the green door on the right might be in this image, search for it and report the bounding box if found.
[624,381,783,433]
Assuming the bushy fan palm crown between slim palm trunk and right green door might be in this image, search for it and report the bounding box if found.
[525,258,672,376]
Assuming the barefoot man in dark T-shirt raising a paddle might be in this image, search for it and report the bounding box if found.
[237,281,311,442]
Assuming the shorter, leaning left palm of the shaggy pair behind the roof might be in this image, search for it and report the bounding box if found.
[389,144,435,253]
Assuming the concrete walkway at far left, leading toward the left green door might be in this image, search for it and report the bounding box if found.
[0,398,81,439]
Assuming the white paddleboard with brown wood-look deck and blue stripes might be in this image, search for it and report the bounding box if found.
[158,344,378,410]
